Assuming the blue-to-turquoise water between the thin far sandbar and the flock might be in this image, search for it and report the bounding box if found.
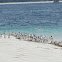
[0,3,62,40]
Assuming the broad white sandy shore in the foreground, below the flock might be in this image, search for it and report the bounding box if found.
[0,37,62,62]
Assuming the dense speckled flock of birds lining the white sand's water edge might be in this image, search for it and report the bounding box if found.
[0,32,62,47]
